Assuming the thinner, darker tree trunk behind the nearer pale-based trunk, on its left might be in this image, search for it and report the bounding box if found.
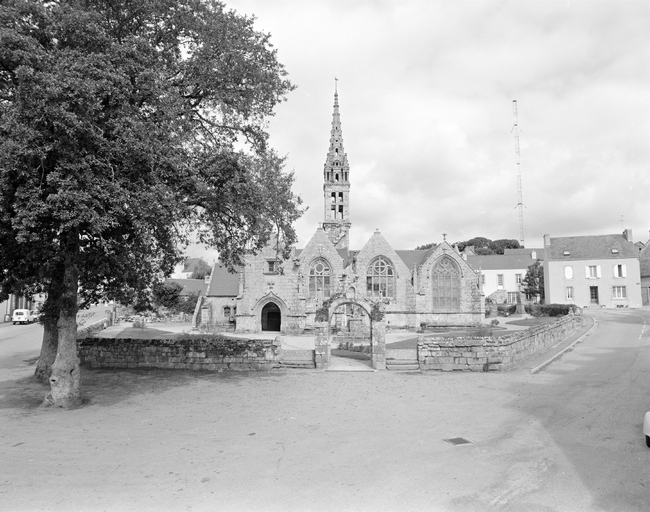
[34,265,65,384]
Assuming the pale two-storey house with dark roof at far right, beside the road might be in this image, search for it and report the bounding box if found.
[543,229,642,308]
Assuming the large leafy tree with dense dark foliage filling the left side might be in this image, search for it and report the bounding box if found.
[0,0,300,406]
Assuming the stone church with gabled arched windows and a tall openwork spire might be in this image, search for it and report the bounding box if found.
[202,90,485,333]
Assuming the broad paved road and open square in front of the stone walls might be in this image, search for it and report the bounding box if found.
[0,310,650,512]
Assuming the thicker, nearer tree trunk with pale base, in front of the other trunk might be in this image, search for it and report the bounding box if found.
[43,238,81,408]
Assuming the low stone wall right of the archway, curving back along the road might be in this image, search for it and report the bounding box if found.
[418,315,582,372]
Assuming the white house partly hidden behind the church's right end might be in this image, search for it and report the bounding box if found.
[464,248,544,304]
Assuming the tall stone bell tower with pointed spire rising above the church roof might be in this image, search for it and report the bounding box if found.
[323,80,352,249]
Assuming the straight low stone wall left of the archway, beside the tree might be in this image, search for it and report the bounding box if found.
[78,338,282,371]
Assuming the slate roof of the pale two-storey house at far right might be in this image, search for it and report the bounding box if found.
[547,235,639,260]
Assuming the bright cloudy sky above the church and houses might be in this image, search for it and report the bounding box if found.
[190,0,650,262]
